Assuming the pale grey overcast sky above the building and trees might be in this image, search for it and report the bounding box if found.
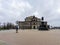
[0,0,60,26]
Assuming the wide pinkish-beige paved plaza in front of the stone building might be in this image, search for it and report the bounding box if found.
[0,29,60,45]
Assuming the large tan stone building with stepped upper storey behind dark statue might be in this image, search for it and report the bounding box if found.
[17,16,47,29]
